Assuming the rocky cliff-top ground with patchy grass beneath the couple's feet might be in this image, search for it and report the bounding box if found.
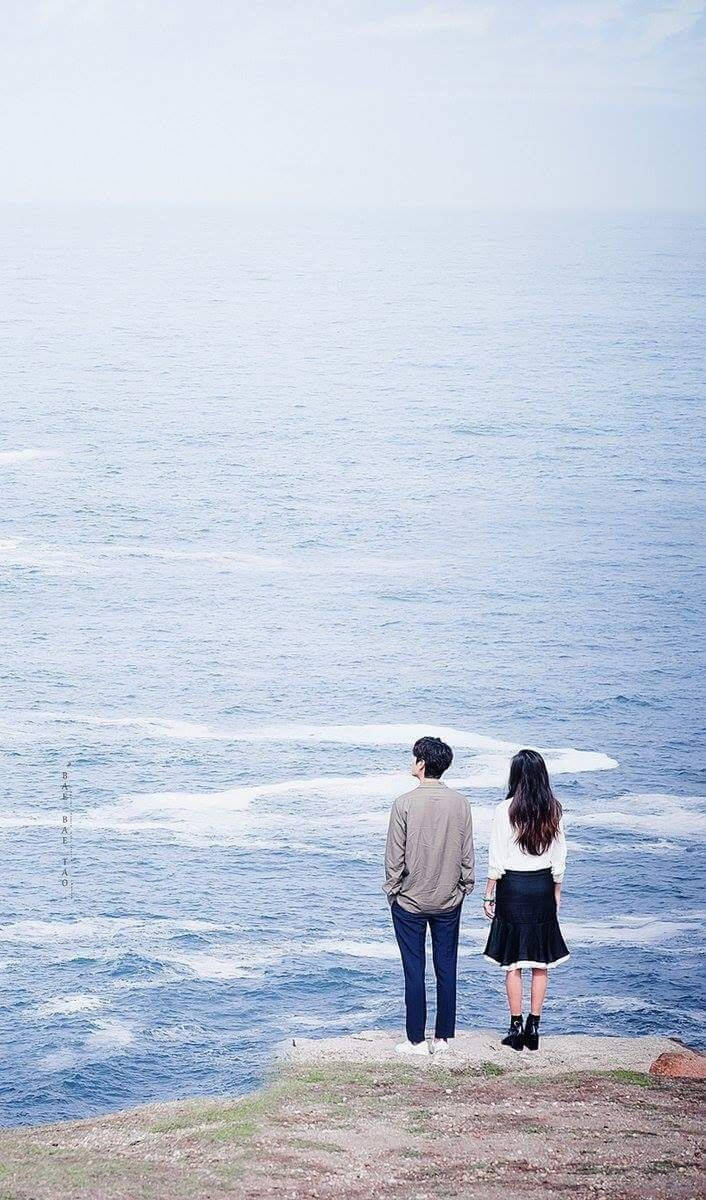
[0,1033,706,1200]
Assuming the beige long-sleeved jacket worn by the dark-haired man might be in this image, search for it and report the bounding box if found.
[383,779,475,912]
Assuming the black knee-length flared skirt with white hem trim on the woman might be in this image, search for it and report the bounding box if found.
[485,868,569,971]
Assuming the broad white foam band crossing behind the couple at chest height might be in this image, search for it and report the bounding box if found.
[0,787,706,862]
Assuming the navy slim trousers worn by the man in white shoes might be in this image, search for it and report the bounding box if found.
[390,900,463,1043]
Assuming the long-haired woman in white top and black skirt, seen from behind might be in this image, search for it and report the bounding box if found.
[483,750,569,1050]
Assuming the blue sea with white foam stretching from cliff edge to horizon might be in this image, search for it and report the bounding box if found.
[0,209,706,1123]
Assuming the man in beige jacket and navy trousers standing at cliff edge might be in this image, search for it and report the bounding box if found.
[383,738,475,1055]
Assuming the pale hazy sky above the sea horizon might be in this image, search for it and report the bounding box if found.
[0,0,706,210]
